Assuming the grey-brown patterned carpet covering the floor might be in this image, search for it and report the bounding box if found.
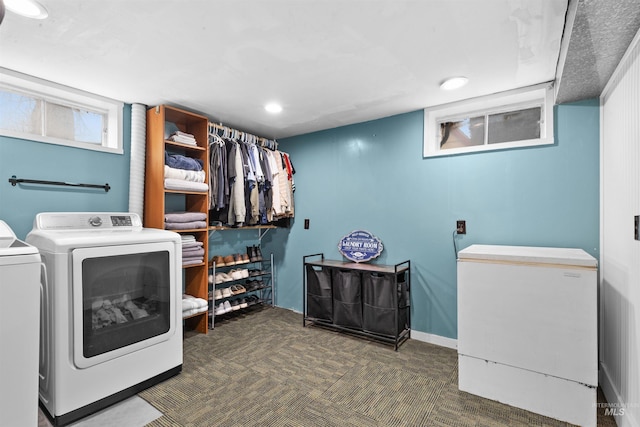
[140,307,615,427]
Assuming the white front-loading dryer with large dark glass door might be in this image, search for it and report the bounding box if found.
[26,212,183,425]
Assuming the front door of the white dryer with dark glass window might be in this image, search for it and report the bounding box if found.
[72,242,178,368]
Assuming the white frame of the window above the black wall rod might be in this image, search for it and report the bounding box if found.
[0,68,124,154]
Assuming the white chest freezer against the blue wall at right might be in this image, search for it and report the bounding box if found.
[457,245,598,426]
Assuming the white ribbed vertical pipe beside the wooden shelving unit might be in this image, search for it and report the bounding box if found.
[129,104,147,218]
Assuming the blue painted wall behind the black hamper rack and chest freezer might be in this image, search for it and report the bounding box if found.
[263,99,599,338]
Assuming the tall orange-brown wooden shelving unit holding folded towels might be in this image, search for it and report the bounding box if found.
[144,105,209,333]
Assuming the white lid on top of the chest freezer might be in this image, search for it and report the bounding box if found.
[458,245,598,267]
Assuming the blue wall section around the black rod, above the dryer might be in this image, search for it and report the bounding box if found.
[0,105,131,239]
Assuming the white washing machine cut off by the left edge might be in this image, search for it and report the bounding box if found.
[0,221,41,426]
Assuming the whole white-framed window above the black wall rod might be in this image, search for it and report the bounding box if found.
[0,69,123,154]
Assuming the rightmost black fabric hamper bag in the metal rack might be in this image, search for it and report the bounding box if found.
[362,272,409,336]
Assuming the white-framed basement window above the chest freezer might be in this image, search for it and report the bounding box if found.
[423,84,554,157]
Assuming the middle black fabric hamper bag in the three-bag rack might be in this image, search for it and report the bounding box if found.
[332,268,362,329]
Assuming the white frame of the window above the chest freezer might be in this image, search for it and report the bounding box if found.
[423,83,554,157]
